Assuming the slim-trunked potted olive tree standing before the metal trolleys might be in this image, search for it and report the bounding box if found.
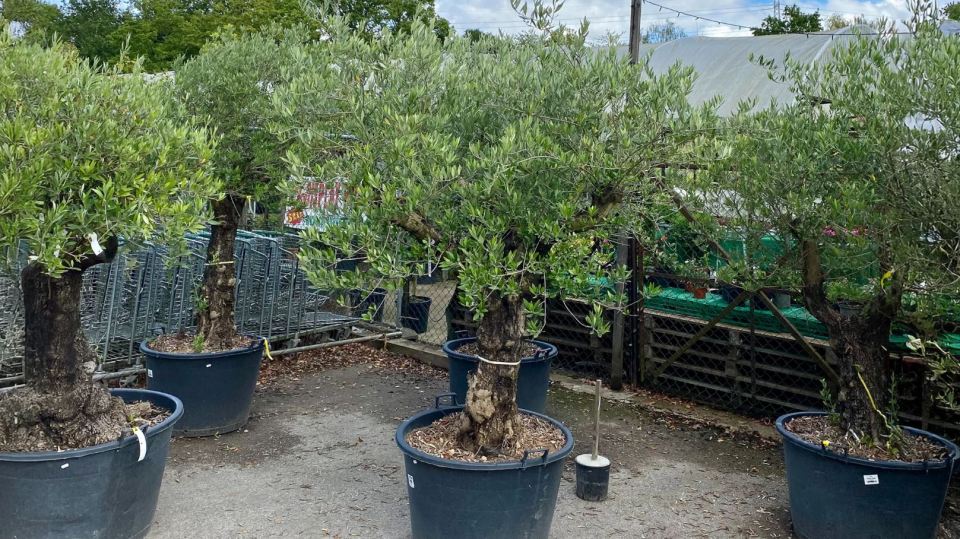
[140,29,320,436]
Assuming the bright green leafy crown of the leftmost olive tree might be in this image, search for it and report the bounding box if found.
[0,24,219,275]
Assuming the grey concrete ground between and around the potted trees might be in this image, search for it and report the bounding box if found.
[149,348,790,539]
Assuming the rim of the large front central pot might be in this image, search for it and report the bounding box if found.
[394,406,574,472]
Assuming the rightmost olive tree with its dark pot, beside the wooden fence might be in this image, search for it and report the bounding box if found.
[690,10,960,537]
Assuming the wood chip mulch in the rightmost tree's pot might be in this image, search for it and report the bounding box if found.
[785,416,947,462]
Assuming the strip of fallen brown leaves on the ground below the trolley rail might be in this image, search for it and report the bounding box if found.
[257,343,447,385]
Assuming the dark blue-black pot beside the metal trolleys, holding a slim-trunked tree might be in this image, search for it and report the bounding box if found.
[140,338,264,436]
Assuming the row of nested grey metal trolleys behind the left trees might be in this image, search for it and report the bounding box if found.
[0,231,358,387]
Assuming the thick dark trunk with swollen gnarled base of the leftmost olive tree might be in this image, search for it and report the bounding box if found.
[0,251,127,451]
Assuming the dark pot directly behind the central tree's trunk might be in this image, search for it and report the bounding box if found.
[443,337,557,413]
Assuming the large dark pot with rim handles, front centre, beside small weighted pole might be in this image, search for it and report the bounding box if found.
[396,397,573,539]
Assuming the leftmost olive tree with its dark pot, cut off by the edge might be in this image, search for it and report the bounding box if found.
[0,26,218,537]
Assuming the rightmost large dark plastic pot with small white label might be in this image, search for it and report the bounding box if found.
[777,412,960,539]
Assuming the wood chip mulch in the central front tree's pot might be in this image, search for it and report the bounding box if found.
[407,412,567,463]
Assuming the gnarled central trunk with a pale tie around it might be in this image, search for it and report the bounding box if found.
[460,296,525,454]
